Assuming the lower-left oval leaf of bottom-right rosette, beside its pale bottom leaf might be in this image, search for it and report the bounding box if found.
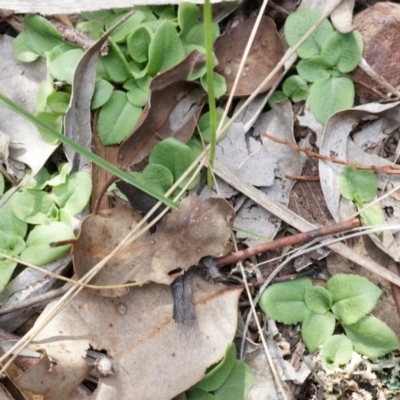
[301,311,335,353]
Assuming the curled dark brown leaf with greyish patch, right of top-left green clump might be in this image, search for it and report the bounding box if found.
[118,51,205,169]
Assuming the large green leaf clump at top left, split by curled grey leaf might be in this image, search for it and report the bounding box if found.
[13,2,226,145]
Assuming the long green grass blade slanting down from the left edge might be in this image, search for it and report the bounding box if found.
[0,92,178,209]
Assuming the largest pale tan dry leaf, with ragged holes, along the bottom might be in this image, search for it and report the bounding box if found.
[18,276,242,400]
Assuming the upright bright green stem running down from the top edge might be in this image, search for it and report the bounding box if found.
[204,0,217,187]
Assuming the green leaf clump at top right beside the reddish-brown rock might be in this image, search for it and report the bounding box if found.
[270,9,363,124]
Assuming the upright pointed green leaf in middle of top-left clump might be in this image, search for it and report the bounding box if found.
[147,20,185,76]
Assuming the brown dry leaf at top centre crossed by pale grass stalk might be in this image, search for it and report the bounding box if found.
[215,16,285,96]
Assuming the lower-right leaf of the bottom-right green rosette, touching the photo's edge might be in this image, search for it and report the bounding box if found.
[343,316,399,358]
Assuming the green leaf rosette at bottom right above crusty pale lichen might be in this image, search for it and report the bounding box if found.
[260,274,399,369]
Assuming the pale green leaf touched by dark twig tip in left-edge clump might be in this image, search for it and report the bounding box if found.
[20,221,75,265]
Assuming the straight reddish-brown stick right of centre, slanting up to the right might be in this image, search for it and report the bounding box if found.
[214,219,361,267]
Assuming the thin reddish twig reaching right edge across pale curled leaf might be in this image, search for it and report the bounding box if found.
[261,132,400,175]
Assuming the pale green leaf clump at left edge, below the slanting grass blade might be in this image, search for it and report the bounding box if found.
[0,164,92,292]
